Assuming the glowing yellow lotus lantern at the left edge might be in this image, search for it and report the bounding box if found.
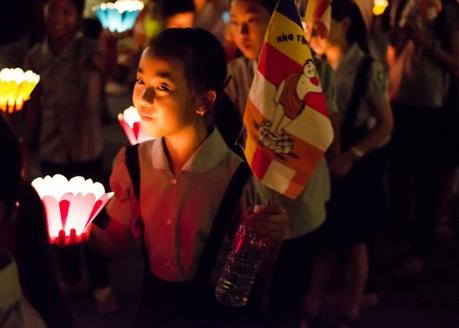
[0,68,40,113]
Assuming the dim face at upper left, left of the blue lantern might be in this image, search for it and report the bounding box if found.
[44,0,80,39]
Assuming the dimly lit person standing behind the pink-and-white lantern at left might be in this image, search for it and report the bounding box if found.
[24,0,115,312]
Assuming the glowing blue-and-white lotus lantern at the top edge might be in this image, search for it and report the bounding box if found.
[92,0,144,33]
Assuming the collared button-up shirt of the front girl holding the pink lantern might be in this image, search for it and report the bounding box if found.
[107,129,242,282]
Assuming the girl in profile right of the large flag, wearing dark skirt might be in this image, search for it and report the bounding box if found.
[304,1,392,327]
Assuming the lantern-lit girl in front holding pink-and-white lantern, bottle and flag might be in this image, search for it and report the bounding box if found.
[92,29,288,327]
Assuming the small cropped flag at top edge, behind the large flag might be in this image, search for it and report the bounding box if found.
[304,0,332,37]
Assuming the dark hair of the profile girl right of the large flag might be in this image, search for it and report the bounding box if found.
[332,0,369,53]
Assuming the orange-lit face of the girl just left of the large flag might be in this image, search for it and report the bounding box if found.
[230,0,270,60]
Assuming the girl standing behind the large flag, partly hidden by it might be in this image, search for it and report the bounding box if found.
[225,0,336,326]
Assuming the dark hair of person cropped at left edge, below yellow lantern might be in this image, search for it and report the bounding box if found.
[0,115,22,214]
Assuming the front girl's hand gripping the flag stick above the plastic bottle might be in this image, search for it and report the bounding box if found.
[245,205,290,241]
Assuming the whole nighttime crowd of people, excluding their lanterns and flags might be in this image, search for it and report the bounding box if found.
[0,0,459,328]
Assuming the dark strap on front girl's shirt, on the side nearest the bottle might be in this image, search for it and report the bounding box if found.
[194,161,251,284]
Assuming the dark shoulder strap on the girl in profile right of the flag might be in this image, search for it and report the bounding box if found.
[341,56,373,149]
